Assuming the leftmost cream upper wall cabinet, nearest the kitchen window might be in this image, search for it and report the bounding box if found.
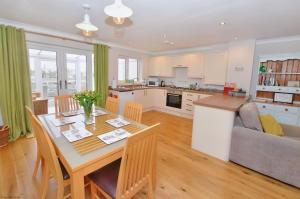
[148,56,174,77]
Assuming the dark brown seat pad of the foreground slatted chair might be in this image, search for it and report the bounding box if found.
[88,159,121,198]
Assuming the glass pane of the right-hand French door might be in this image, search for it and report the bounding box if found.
[65,54,87,93]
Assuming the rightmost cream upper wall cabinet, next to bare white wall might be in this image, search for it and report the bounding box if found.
[203,51,227,85]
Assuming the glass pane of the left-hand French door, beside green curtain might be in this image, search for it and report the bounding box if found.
[29,49,58,107]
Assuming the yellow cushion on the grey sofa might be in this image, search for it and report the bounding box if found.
[260,115,284,136]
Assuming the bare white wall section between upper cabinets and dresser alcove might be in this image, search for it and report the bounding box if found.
[227,40,255,93]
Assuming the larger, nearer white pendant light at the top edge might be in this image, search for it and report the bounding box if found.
[104,0,133,25]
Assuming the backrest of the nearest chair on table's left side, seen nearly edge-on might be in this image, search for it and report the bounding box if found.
[26,106,64,187]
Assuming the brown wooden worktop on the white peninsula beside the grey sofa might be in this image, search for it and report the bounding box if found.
[194,94,249,112]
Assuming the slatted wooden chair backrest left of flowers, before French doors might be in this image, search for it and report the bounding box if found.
[54,95,80,115]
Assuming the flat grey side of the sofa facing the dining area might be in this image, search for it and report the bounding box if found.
[229,127,300,187]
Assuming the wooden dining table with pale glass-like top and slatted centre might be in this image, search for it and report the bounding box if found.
[38,107,147,199]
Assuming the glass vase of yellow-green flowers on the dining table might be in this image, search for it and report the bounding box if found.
[74,90,100,124]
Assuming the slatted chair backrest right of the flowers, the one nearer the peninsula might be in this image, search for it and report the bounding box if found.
[124,102,143,122]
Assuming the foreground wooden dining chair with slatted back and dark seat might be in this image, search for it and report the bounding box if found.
[88,124,159,199]
